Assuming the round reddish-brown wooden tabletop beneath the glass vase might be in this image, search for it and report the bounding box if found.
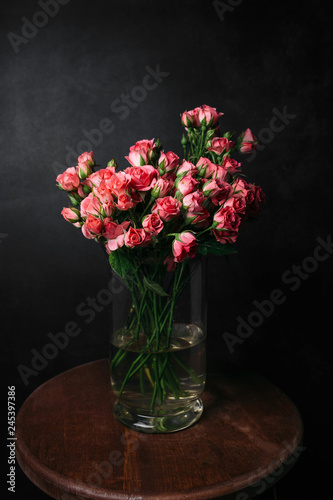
[16,359,302,500]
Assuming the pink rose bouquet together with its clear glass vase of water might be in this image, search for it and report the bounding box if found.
[57,105,264,432]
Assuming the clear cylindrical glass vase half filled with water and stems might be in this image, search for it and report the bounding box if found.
[110,257,206,433]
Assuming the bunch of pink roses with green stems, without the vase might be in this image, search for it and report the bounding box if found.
[57,105,264,422]
